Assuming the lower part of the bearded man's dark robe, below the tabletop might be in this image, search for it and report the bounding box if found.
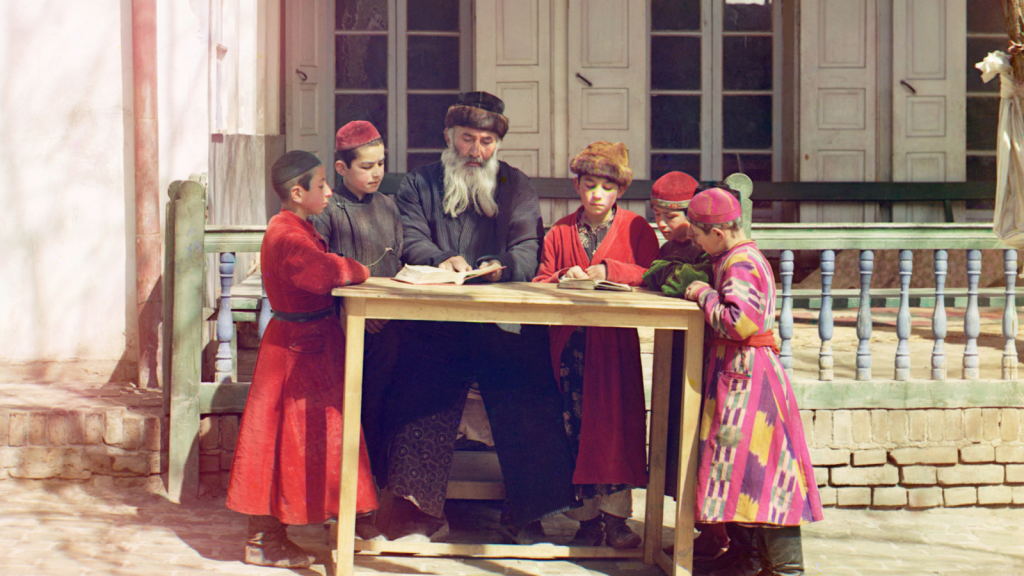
[385,322,575,526]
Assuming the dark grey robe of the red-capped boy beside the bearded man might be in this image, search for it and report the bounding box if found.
[309,187,402,478]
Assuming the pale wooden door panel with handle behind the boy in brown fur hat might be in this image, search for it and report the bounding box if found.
[558,0,649,178]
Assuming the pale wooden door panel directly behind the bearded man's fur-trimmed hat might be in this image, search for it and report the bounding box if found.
[475,0,552,177]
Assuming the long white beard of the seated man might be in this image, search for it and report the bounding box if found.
[441,145,498,218]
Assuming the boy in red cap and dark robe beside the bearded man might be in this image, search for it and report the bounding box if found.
[309,120,402,487]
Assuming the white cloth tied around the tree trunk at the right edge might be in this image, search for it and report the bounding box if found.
[975,51,1024,249]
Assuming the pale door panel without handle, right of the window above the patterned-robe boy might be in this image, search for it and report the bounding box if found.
[800,0,878,221]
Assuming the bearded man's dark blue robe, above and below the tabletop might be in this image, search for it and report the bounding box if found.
[386,162,575,526]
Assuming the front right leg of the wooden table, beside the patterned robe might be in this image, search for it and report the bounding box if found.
[669,319,703,576]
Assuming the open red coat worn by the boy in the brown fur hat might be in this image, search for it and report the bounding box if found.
[534,208,658,486]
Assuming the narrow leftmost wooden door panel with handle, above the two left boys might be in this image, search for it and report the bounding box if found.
[285,0,334,169]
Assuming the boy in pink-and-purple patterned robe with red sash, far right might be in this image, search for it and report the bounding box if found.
[685,188,822,575]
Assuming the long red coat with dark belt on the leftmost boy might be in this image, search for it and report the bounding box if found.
[227,210,377,524]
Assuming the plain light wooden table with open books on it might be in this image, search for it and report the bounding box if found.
[332,278,705,576]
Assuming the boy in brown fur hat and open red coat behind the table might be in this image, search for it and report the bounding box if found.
[534,141,658,548]
